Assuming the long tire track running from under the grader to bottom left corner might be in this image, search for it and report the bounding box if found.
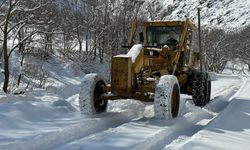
[0,111,138,150]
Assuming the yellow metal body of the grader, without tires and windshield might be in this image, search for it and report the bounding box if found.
[104,19,198,101]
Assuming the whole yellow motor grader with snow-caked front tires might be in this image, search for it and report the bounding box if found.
[79,19,211,119]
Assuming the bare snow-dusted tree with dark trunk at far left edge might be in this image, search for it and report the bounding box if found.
[0,0,46,93]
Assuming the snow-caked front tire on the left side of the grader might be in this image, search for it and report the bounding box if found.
[79,74,107,115]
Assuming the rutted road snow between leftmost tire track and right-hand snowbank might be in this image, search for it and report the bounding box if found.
[53,76,245,150]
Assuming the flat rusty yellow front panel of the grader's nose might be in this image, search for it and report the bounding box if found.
[111,56,132,96]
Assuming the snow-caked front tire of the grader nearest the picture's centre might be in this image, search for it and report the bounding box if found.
[154,75,180,119]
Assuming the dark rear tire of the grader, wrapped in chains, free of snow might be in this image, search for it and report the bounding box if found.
[192,72,211,107]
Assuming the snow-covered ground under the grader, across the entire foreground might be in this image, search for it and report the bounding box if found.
[0,75,250,150]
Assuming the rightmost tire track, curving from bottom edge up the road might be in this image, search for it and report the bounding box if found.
[133,77,246,150]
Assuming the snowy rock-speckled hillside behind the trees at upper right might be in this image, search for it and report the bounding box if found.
[146,0,250,29]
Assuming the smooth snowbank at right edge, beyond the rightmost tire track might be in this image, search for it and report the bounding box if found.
[178,77,250,150]
